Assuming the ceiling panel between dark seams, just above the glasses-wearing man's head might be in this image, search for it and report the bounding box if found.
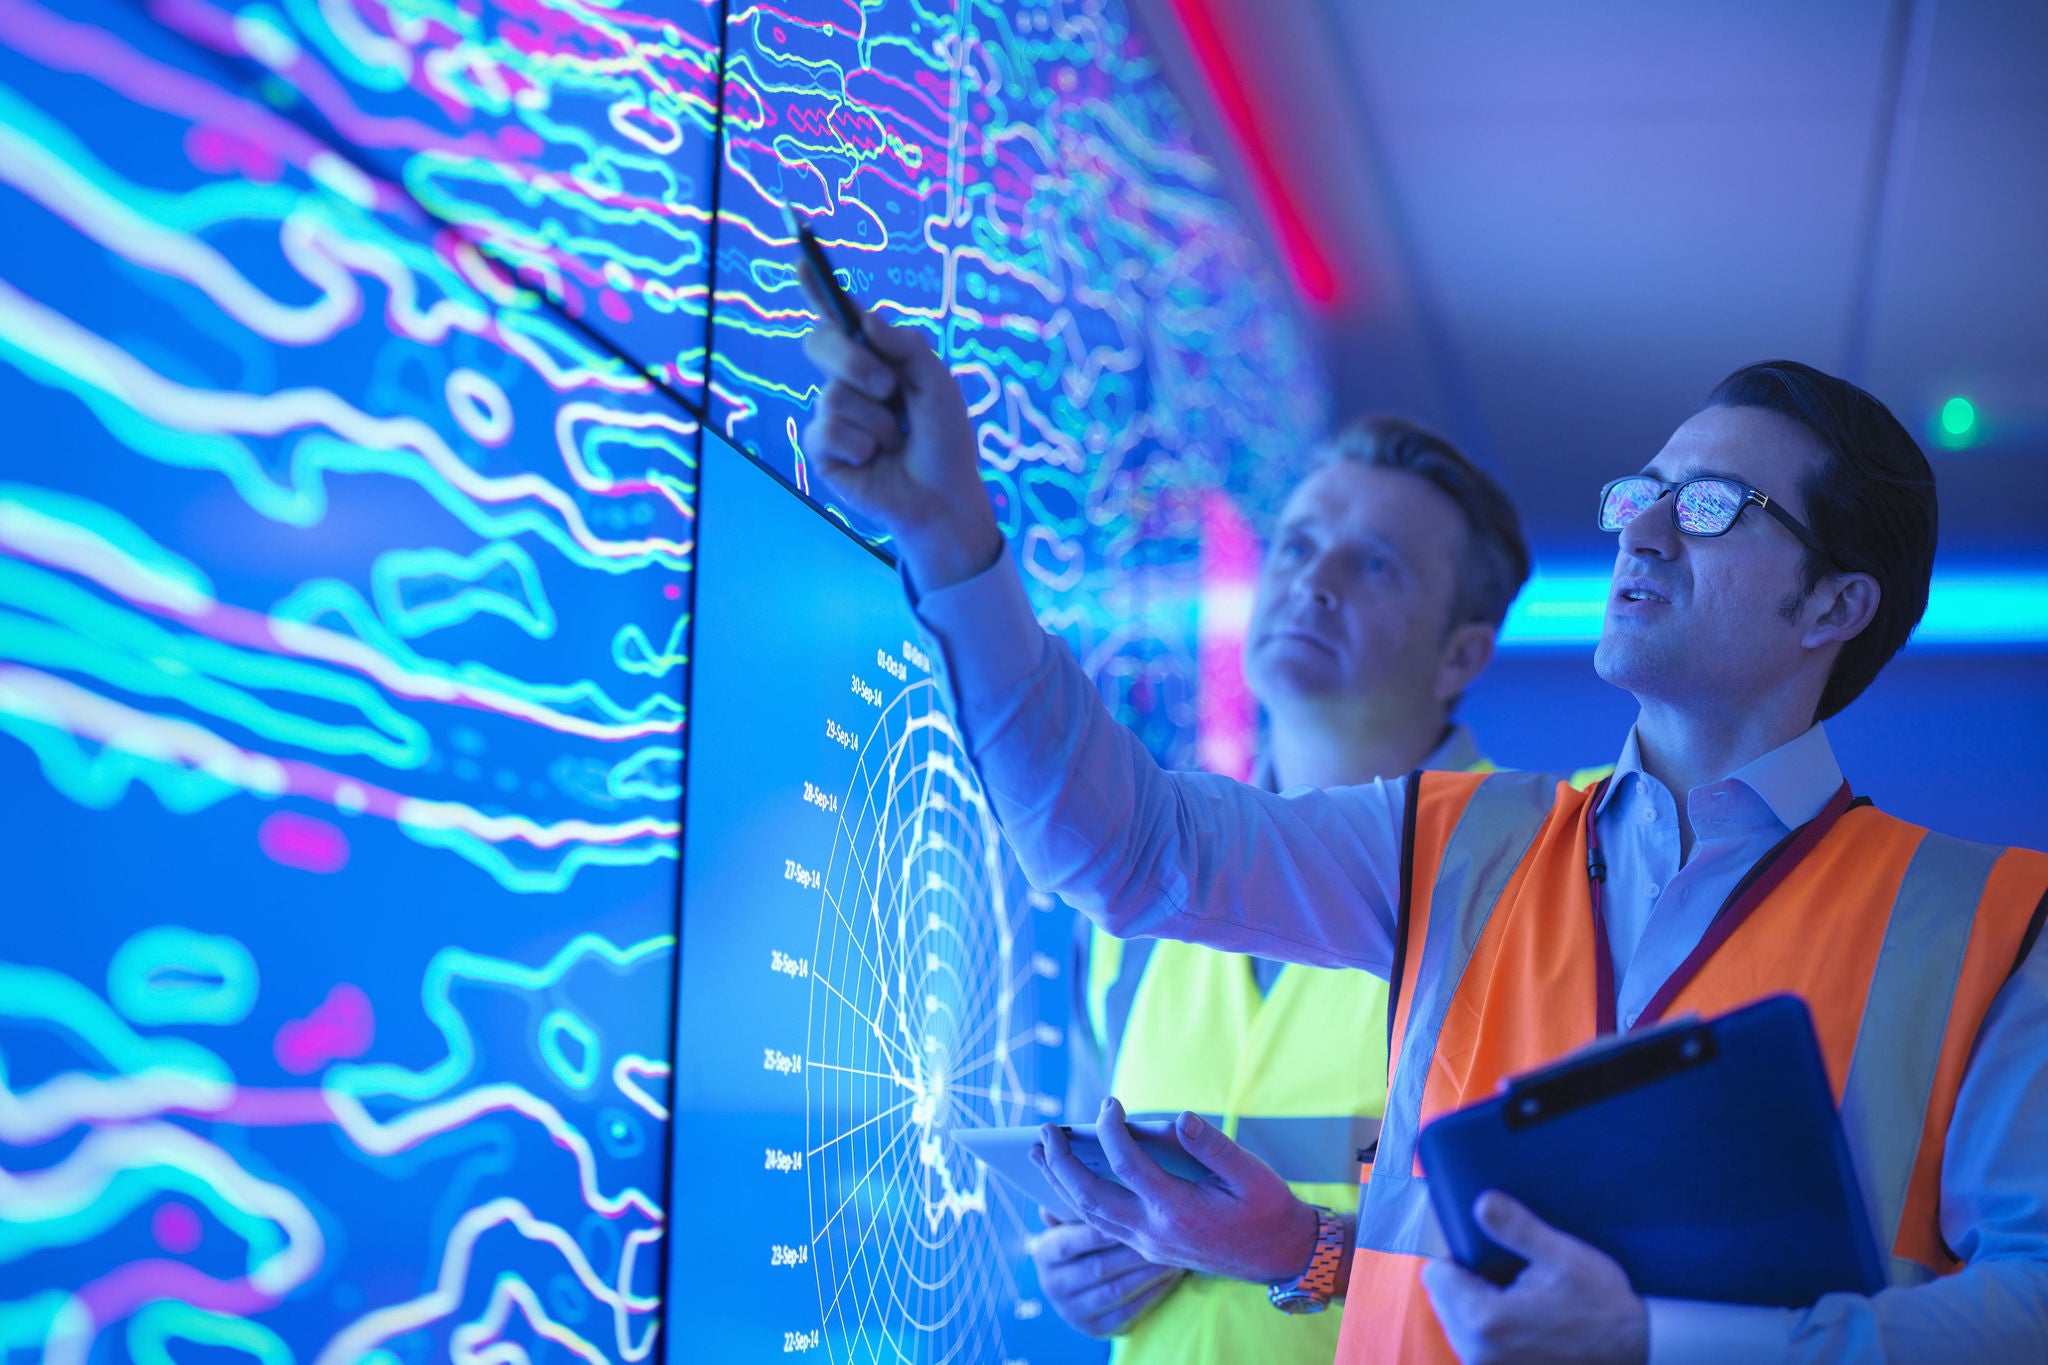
[1359,115,1868,534]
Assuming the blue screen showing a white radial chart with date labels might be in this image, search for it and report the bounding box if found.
[668,438,1065,1361]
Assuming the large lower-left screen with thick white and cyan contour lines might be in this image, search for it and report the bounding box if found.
[0,0,698,1365]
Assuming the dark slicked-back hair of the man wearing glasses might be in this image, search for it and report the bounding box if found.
[1706,360,1939,720]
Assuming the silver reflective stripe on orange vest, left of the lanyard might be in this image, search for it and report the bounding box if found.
[1358,774,1556,1257]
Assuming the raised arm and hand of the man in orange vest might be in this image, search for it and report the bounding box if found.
[805,272,1405,976]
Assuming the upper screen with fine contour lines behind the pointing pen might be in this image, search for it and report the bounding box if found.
[709,0,1327,765]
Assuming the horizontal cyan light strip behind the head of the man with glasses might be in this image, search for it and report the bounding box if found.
[1501,569,2048,649]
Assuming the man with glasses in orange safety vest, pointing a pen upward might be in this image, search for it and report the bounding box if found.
[807,298,2048,1363]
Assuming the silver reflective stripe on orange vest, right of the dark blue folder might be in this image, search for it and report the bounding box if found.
[1841,835,2005,1283]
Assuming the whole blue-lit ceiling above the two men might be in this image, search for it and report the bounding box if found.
[1155,0,2048,555]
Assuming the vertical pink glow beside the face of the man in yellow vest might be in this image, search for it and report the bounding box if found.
[1194,491,1260,778]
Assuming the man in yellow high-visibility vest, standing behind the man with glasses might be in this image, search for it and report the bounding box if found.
[1032,417,1530,1365]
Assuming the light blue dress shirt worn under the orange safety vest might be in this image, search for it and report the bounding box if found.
[915,557,2048,1365]
